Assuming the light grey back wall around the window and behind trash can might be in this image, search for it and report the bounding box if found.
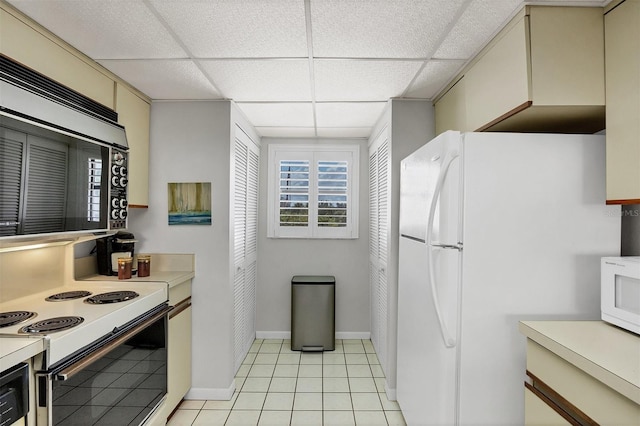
[256,138,370,338]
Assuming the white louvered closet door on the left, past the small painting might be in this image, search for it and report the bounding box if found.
[233,128,259,370]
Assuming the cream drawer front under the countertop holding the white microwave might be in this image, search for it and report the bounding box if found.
[527,340,640,426]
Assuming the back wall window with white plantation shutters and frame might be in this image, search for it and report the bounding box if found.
[267,145,359,238]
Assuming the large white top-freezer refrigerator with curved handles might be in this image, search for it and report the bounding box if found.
[397,131,620,426]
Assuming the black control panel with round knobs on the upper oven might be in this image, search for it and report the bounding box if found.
[109,148,129,229]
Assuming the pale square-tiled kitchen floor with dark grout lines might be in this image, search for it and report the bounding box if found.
[168,339,405,426]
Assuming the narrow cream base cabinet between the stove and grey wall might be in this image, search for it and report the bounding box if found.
[163,279,192,417]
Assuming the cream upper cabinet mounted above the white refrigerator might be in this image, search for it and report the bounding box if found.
[436,6,605,133]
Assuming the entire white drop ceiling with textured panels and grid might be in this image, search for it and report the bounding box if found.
[8,0,609,138]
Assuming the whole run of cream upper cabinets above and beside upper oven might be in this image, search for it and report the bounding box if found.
[0,2,150,207]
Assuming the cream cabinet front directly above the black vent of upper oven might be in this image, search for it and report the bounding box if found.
[0,3,114,109]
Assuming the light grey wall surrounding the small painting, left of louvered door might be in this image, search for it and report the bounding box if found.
[129,101,239,399]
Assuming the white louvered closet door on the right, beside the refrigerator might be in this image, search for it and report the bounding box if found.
[369,129,391,372]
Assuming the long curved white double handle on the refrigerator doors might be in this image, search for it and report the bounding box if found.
[426,151,462,348]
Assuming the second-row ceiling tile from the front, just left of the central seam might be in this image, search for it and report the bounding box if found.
[200,59,311,101]
